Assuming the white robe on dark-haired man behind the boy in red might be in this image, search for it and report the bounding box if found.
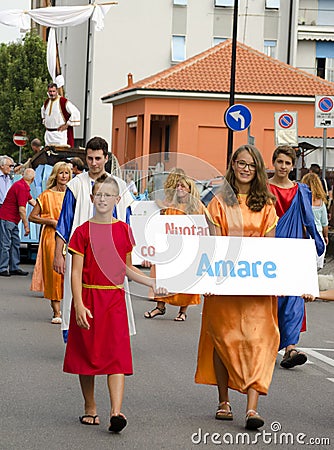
[61,172,136,335]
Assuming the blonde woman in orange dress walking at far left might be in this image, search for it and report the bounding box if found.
[29,161,72,324]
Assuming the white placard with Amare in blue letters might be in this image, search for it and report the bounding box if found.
[156,235,319,296]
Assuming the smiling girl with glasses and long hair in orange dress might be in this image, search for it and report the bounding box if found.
[195,145,279,429]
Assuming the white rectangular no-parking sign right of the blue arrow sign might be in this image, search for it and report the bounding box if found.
[274,111,298,146]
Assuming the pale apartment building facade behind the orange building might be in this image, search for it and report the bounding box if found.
[33,0,334,146]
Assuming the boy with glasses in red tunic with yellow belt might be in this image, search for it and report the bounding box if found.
[64,175,166,432]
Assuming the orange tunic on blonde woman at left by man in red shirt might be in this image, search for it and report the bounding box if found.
[30,189,65,301]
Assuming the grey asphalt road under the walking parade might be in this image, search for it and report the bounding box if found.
[0,265,334,450]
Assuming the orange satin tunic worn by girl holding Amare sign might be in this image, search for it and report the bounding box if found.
[195,195,279,394]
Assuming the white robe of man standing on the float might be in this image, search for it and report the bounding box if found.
[41,95,80,146]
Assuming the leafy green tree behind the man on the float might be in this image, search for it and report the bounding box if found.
[0,31,49,159]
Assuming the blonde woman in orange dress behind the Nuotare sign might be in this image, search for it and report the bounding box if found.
[144,176,205,322]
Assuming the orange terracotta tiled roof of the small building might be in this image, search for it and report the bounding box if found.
[103,39,334,99]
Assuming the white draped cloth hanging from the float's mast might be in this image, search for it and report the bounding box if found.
[0,2,113,87]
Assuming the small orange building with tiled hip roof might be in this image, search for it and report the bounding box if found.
[102,40,334,179]
